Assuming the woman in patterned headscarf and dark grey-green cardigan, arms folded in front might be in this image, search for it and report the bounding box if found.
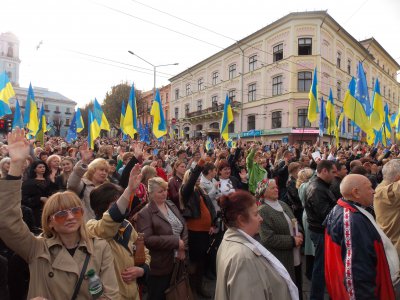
[256,179,303,299]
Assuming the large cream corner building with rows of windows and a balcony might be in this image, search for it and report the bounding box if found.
[170,11,400,142]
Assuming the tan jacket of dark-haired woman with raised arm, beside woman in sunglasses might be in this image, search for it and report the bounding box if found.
[86,212,150,300]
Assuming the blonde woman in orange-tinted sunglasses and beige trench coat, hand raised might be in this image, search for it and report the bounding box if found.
[0,128,119,299]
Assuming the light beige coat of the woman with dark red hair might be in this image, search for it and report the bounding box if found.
[215,228,291,300]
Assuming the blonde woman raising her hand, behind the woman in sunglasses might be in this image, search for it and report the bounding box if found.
[67,143,109,222]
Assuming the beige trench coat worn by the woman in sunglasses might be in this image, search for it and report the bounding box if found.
[0,180,119,299]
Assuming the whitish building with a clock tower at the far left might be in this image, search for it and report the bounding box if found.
[0,32,77,136]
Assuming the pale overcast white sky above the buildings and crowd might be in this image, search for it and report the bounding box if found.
[0,0,400,107]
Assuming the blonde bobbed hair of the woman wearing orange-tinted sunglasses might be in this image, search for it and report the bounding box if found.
[42,191,92,250]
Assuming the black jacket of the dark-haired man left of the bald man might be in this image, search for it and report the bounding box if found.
[305,176,337,233]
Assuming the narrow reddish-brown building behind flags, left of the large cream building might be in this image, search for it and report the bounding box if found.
[137,84,171,127]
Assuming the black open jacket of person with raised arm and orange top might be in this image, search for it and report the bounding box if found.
[179,165,217,225]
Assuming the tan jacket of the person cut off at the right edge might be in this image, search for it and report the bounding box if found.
[374,180,400,257]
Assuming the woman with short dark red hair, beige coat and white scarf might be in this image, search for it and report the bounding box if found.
[215,191,298,300]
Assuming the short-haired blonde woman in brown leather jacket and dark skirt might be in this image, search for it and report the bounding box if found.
[136,177,188,300]
